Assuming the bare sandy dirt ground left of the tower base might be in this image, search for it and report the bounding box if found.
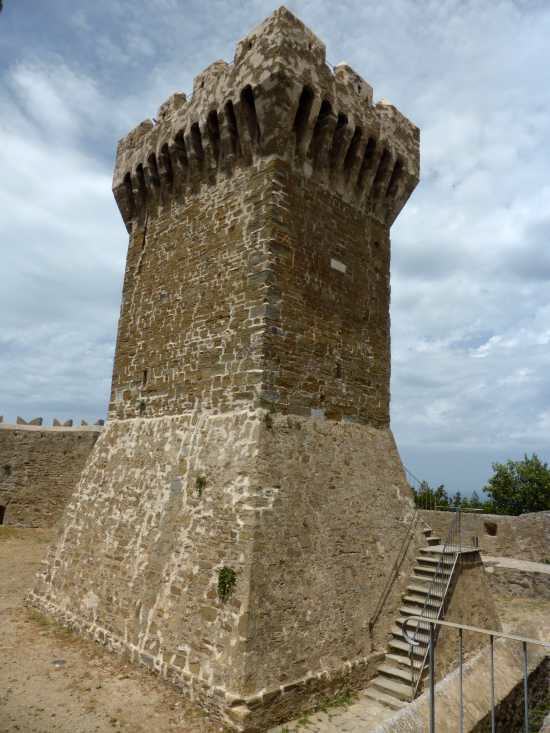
[0,527,223,733]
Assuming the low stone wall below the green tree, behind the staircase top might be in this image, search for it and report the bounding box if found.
[421,510,550,562]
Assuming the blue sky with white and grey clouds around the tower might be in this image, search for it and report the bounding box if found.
[0,0,550,493]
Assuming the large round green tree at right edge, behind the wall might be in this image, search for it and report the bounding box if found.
[484,453,550,515]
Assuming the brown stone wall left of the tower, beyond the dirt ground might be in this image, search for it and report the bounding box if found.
[0,422,101,527]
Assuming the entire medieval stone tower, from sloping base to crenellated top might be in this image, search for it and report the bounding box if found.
[31,8,419,730]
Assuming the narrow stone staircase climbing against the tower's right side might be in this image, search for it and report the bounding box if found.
[364,527,454,710]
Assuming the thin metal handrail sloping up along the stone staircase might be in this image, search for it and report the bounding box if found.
[409,508,462,700]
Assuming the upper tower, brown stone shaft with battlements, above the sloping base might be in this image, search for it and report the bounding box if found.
[110,8,419,427]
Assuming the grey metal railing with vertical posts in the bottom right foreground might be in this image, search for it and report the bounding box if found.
[403,616,550,733]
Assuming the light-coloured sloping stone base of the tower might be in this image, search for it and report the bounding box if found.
[29,410,413,730]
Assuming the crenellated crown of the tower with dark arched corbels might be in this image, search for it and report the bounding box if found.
[113,7,419,228]
